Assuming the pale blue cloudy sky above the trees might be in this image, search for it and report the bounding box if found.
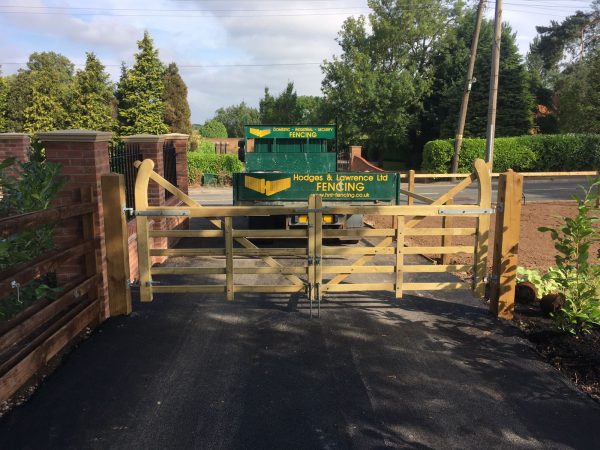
[0,0,591,123]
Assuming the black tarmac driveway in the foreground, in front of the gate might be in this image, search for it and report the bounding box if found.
[0,230,600,450]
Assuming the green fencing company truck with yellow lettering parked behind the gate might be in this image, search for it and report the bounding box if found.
[233,125,400,229]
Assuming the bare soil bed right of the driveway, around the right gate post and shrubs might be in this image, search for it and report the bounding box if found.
[365,202,600,401]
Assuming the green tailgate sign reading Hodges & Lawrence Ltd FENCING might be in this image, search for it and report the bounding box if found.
[234,172,398,202]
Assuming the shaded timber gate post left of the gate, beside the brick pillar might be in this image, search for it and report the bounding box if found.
[102,173,132,316]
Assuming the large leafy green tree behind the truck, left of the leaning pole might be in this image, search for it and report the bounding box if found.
[322,0,462,160]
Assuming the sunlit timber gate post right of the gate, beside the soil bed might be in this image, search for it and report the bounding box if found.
[490,170,523,320]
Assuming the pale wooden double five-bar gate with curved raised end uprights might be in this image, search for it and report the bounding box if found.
[134,160,493,311]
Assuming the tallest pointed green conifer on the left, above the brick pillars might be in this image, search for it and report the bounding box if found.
[118,31,169,135]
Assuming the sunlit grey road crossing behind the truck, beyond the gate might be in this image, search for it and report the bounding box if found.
[190,177,589,205]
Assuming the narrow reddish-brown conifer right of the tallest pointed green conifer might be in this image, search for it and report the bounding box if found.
[163,63,192,134]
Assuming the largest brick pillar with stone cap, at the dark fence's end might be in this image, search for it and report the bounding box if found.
[38,130,112,318]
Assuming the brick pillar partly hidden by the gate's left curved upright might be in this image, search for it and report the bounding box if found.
[121,134,167,264]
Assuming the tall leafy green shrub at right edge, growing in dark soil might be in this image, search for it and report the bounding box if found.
[539,179,600,334]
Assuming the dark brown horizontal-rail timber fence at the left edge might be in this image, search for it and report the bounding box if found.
[0,189,103,401]
